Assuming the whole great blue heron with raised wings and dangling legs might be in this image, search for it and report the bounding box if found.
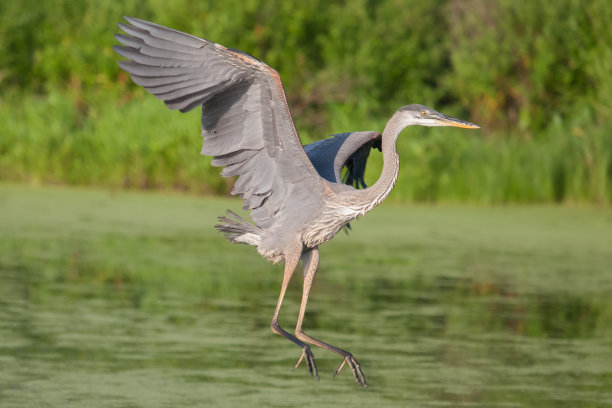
[114,17,478,386]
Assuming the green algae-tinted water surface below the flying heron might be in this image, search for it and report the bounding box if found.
[0,185,612,408]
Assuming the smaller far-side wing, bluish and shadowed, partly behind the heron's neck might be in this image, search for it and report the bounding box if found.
[304,132,381,188]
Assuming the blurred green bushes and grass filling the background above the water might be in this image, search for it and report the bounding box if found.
[0,0,612,203]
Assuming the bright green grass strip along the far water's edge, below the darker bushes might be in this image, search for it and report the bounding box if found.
[0,93,612,203]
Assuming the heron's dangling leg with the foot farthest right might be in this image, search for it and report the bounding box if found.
[295,247,368,387]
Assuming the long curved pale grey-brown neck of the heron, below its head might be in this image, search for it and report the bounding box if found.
[357,113,406,211]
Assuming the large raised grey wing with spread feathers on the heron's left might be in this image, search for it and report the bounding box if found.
[113,17,323,226]
